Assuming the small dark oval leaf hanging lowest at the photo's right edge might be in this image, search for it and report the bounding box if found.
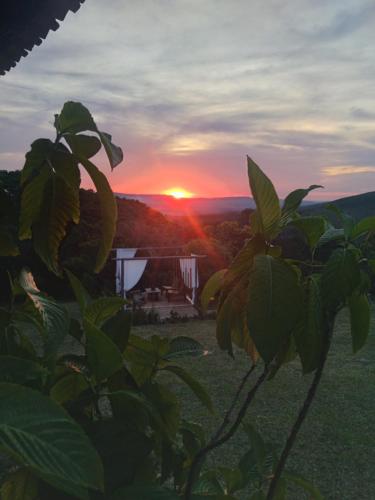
[349,293,371,352]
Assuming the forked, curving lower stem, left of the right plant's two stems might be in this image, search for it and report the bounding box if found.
[184,366,269,500]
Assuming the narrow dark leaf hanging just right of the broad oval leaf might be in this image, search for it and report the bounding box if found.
[294,276,324,373]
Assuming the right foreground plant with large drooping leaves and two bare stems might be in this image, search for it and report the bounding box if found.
[185,158,375,500]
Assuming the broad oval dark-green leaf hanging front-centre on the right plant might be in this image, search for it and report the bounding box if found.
[247,255,302,362]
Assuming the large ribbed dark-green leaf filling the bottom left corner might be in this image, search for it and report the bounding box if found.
[0,383,103,499]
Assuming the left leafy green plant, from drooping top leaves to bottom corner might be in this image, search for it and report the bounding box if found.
[0,102,213,500]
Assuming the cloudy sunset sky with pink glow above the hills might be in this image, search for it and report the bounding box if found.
[0,0,375,199]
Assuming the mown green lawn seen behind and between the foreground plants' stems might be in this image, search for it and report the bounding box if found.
[133,314,375,500]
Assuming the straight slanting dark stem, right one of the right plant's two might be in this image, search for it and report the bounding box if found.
[266,328,332,500]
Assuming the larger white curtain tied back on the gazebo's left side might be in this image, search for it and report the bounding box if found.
[116,248,147,294]
